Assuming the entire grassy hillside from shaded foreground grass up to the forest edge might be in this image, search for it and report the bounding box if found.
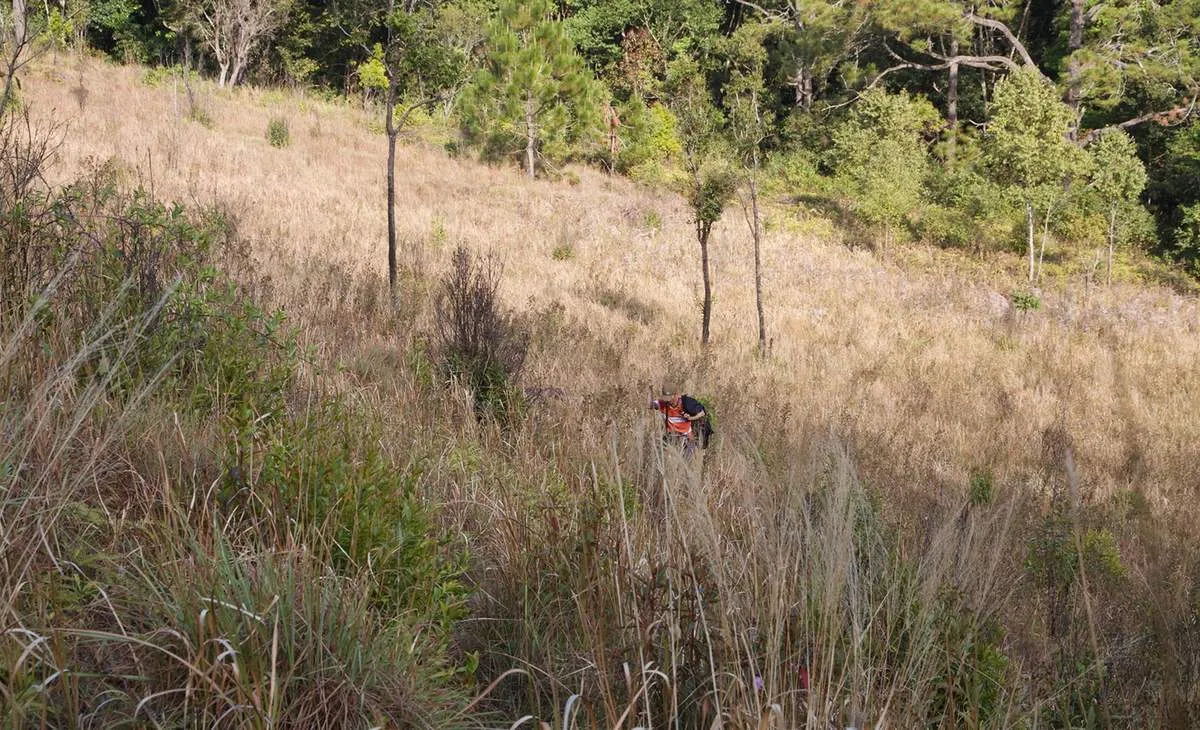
[0,60,1200,728]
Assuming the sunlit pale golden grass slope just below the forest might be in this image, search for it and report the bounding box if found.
[25,59,1200,514]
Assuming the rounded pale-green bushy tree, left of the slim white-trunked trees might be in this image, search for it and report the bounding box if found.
[830,89,938,234]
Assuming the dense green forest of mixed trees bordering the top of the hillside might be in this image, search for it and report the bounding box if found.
[42,0,1200,280]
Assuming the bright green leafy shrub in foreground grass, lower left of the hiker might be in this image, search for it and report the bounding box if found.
[238,400,467,614]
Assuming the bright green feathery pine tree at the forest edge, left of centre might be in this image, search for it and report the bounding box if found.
[458,0,601,176]
